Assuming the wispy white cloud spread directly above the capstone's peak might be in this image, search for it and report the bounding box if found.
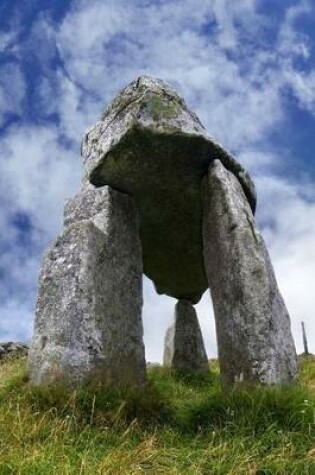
[48,0,310,151]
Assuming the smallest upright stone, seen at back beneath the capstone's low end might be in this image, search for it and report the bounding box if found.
[163,300,209,373]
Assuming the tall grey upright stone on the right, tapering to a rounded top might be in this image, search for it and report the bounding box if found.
[202,160,297,384]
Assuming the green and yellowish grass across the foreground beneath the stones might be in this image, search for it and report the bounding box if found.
[0,357,315,475]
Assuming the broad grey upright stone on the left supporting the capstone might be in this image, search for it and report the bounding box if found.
[29,187,145,386]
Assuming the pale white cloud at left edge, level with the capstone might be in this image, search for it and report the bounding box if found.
[0,122,81,237]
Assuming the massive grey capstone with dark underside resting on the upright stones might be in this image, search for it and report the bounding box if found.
[82,77,256,303]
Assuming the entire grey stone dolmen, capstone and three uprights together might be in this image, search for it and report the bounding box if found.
[29,76,297,386]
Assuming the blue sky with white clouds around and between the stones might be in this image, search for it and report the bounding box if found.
[0,0,315,362]
